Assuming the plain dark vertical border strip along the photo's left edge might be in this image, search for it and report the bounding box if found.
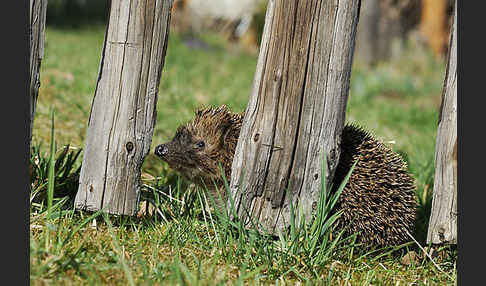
[0,1,30,285]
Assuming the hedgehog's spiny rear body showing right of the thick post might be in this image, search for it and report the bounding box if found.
[333,125,416,246]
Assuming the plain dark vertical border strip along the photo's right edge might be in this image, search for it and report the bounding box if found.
[457,0,474,285]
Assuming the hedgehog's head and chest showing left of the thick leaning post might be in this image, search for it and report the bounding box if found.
[155,105,243,208]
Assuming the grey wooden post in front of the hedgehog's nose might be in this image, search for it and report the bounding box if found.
[75,0,172,215]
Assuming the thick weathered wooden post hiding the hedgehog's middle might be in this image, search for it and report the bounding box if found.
[228,0,360,234]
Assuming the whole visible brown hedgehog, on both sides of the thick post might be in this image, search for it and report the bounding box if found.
[154,105,416,247]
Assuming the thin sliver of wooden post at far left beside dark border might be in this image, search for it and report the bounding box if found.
[29,0,47,152]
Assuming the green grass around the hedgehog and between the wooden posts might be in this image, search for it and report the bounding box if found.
[30,25,457,285]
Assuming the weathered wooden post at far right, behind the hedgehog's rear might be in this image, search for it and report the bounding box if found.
[427,1,457,244]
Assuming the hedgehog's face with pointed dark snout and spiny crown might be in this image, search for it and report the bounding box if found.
[155,107,237,187]
